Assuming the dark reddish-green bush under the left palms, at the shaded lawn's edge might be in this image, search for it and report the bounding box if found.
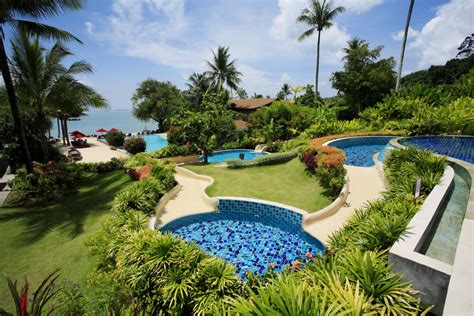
[9,162,79,204]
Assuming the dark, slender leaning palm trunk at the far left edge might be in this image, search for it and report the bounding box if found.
[0,35,33,173]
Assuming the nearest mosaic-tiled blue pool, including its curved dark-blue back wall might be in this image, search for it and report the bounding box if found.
[161,199,324,277]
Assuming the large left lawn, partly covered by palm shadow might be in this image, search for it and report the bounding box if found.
[0,171,130,311]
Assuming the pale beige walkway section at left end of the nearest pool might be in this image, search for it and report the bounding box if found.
[156,167,217,226]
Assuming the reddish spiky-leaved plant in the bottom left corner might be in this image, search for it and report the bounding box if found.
[0,270,59,316]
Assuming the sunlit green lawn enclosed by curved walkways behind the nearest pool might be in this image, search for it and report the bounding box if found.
[186,159,333,213]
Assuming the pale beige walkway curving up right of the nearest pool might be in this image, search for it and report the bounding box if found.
[305,166,384,243]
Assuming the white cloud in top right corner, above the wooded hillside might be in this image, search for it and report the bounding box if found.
[409,0,474,68]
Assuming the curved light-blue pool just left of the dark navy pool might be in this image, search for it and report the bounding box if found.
[326,136,394,167]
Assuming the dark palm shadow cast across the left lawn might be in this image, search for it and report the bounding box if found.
[0,171,129,246]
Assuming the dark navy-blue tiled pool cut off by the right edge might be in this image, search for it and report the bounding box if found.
[398,136,474,163]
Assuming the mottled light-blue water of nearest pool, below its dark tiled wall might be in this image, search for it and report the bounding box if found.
[174,220,319,277]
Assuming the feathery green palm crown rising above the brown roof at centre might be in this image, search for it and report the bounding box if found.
[207,46,242,95]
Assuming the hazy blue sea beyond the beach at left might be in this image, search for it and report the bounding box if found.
[51,110,154,137]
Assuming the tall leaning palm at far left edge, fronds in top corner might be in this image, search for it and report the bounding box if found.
[0,0,84,172]
